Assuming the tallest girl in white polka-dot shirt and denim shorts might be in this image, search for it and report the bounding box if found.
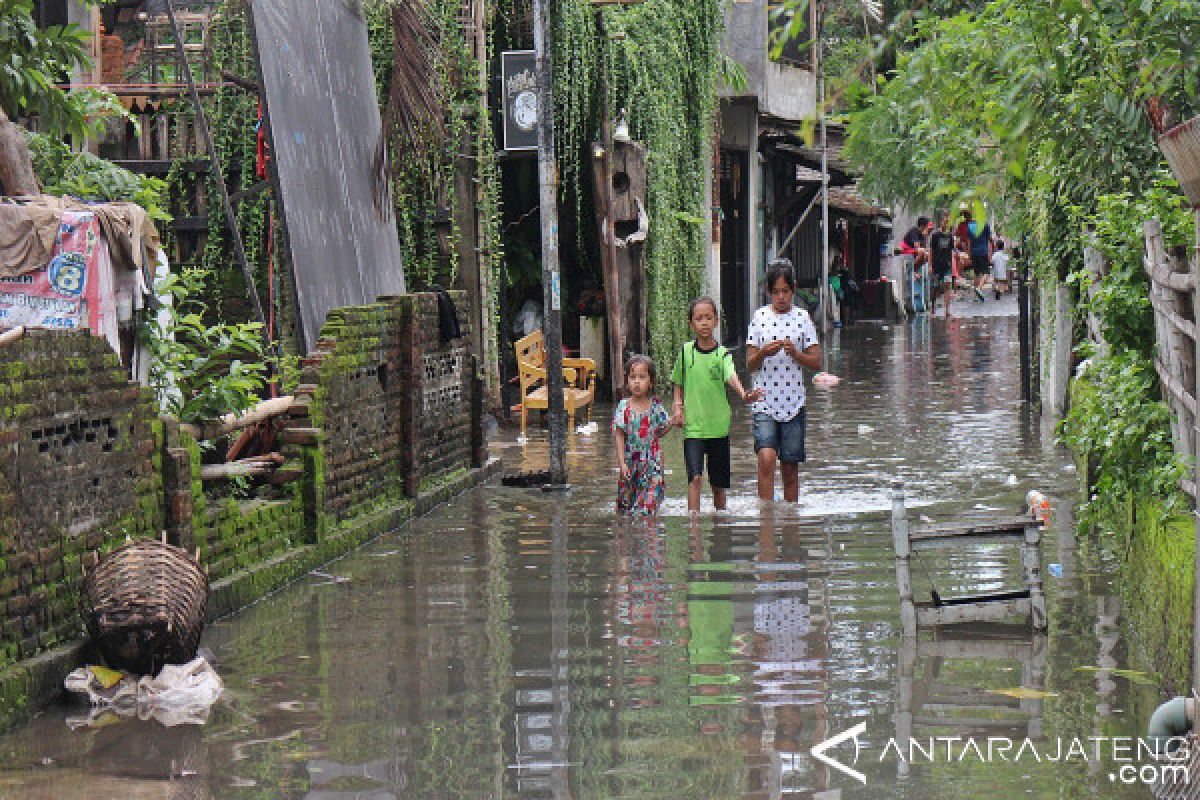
[746,259,821,503]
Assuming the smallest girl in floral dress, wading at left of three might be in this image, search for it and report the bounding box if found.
[612,355,672,517]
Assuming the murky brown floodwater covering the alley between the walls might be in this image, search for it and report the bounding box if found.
[0,307,1157,800]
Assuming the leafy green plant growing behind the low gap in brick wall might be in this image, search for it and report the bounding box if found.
[146,269,266,422]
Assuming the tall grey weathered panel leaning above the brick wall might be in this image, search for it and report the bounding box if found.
[251,0,404,351]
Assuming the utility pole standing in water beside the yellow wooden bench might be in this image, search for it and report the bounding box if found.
[533,0,566,487]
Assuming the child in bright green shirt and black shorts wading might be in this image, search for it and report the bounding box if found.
[671,297,762,511]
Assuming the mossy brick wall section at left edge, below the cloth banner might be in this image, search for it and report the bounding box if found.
[0,331,164,667]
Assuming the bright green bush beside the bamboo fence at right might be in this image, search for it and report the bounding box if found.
[1062,350,1183,522]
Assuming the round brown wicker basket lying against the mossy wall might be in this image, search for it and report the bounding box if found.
[80,539,209,675]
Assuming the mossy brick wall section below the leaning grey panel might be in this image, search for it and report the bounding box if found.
[290,291,481,537]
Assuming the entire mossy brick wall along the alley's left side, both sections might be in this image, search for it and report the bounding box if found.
[0,291,484,681]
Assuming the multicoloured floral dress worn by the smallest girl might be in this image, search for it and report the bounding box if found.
[612,397,671,517]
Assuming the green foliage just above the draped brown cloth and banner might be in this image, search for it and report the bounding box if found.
[29,133,170,222]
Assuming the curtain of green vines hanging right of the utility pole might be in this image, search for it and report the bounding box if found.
[553,0,722,363]
